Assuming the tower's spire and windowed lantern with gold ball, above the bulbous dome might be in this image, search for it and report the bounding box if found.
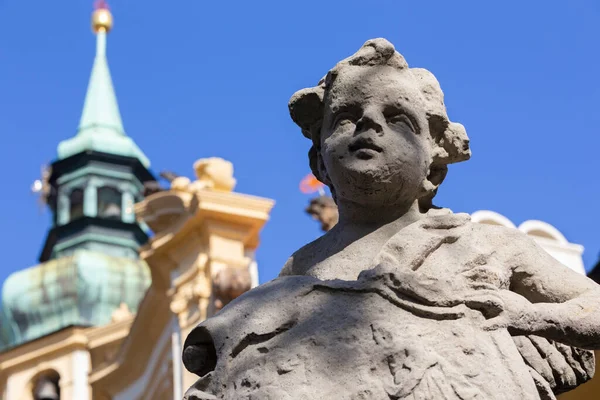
[40,4,154,262]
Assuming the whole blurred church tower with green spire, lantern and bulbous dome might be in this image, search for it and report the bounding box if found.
[0,1,155,400]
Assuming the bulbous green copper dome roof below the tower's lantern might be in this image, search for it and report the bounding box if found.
[0,250,150,351]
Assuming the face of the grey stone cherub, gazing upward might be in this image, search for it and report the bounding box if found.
[320,67,430,206]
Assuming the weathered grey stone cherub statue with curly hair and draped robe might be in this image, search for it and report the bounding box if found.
[184,39,600,400]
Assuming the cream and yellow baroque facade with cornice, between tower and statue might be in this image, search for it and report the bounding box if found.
[89,159,273,400]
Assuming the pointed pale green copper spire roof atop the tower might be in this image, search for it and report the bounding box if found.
[58,32,150,168]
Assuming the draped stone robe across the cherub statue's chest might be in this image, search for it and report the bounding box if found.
[186,214,593,400]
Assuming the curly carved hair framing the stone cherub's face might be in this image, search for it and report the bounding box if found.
[288,39,471,210]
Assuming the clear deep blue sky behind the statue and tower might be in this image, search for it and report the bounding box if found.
[0,0,600,282]
